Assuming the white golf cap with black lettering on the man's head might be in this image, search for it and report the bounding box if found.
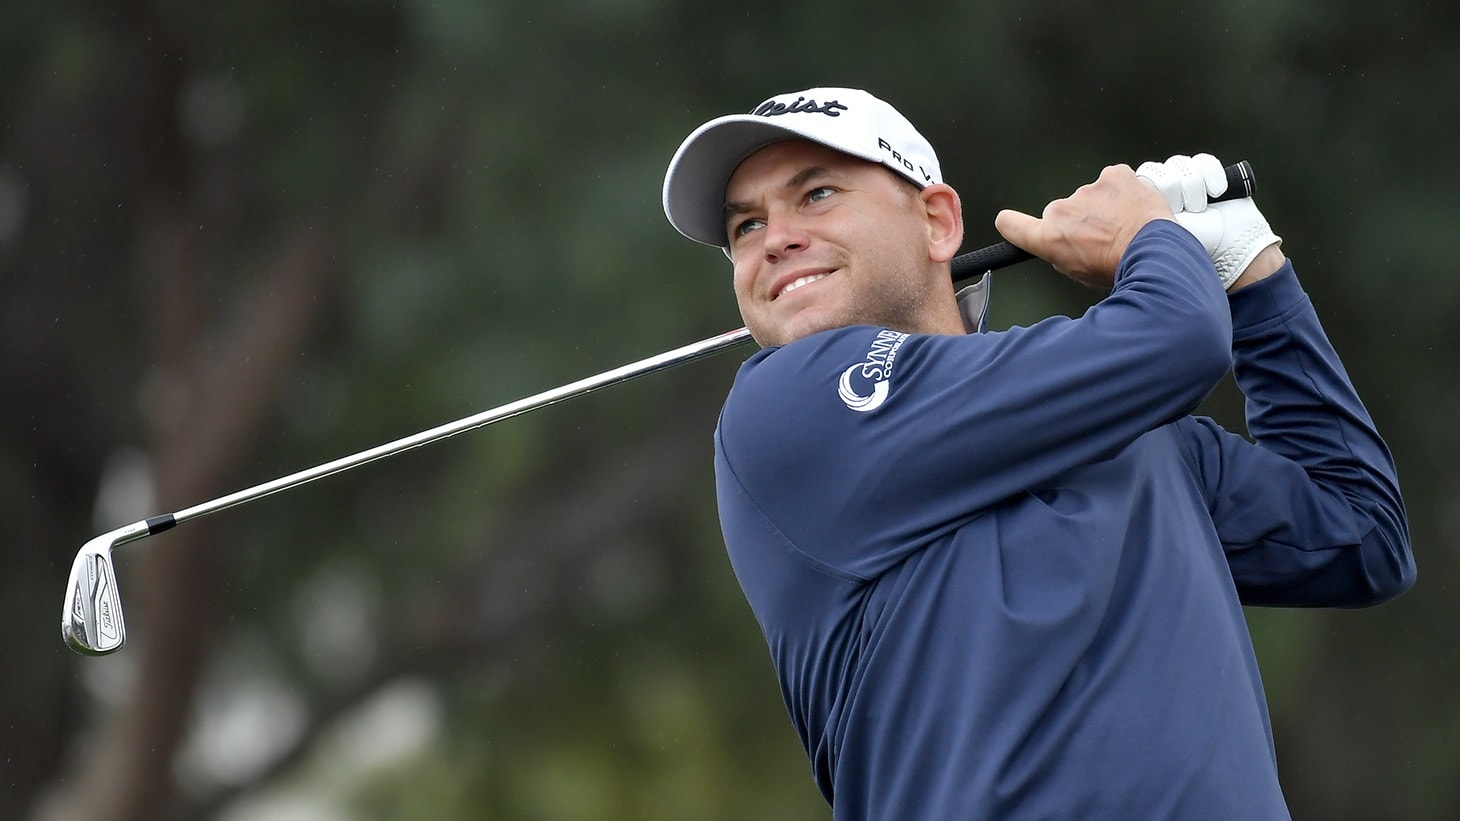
[664,88,943,248]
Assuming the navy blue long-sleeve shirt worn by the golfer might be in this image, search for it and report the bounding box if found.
[715,221,1415,820]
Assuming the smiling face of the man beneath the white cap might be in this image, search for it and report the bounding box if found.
[726,140,956,346]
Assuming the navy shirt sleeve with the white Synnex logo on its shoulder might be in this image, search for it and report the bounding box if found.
[718,221,1231,578]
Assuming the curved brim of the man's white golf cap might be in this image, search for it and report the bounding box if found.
[664,114,870,248]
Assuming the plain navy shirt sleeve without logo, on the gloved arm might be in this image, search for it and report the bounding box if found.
[1180,263,1415,606]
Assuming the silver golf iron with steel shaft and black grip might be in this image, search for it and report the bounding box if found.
[61,161,1254,656]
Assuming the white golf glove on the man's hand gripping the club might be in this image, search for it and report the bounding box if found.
[1136,153,1282,288]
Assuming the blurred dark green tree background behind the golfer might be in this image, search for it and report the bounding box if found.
[0,0,1460,821]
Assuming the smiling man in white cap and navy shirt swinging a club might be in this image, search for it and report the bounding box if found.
[664,89,1415,820]
